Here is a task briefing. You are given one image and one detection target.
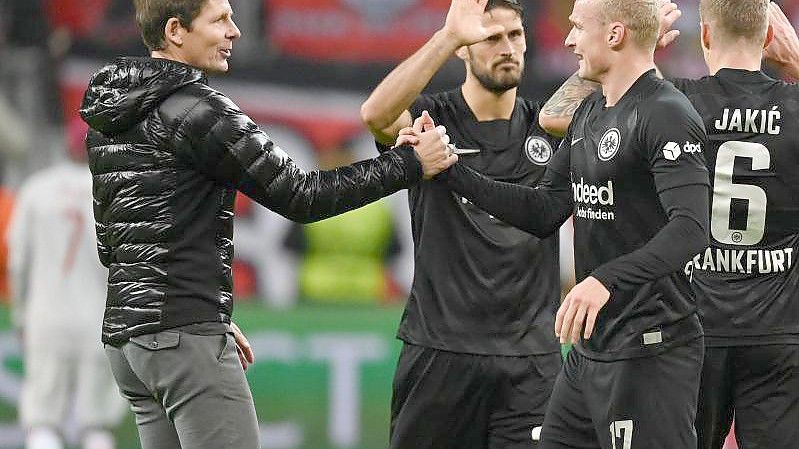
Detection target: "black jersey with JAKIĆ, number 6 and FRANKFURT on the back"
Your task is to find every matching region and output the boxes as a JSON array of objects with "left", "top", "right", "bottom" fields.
[{"left": 673, "top": 69, "right": 799, "bottom": 346}]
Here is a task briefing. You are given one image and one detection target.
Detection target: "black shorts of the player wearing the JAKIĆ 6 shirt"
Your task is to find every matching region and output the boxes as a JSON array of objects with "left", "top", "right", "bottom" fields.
[{"left": 696, "top": 345, "right": 799, "bottom": 449}]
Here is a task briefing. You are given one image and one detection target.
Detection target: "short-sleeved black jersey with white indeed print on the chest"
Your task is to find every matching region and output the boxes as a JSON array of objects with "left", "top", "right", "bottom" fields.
[{"left": 550, "top": 70, "right": 708, "bottom": 360}]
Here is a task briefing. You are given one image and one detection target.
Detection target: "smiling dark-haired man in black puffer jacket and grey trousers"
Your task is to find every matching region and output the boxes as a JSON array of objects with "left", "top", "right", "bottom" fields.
[{"left": 80, "top": 0, "right": 457, "bottom": 449}]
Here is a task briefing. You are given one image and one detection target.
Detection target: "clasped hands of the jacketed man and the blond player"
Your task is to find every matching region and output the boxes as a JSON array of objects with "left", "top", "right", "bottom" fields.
[{"left": 395, "top": 111, "right": 458, "bottom": 179}]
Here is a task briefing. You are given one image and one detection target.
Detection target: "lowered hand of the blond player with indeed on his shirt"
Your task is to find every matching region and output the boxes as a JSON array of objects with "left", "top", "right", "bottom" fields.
[{"left": 555, "top": 276, "right": 610, "bottom": 343}]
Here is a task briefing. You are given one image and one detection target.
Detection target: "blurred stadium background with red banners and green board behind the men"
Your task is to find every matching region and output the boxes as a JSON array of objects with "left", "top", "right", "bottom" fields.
[{"left": 0, "top": 0, "right": 799, "bottom": 449}]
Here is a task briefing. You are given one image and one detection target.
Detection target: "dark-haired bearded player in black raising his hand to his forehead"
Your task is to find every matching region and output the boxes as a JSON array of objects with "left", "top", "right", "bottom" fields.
[{"left": 361, "top": 0, "right": 561, "bottom": 449}]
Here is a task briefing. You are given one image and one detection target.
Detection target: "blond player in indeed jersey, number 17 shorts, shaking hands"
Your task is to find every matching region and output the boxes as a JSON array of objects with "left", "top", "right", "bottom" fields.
[{"left": 440, "top": 0, "right": 709, "bottom": 449}]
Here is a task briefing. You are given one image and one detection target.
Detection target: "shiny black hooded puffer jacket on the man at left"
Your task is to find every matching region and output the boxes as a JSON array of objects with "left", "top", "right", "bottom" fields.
[{"left": 80, "top": 58, "right": 422, "bottom": 345}]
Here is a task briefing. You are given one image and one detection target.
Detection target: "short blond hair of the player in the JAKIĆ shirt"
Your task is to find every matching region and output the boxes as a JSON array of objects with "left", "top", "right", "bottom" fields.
[{"left": 699, "top": 0, "right": 769, "bottom": 44}]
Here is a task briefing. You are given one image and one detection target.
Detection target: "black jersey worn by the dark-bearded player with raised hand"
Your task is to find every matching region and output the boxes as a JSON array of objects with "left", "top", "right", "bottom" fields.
[{"left": 398, "top": 89, "right": 560, "bottom": 355}]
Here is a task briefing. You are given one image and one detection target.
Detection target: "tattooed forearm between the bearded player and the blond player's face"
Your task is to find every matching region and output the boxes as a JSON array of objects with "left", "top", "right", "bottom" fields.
[{"left": 538, "top": 73, "right": 599, "bottom": 137}]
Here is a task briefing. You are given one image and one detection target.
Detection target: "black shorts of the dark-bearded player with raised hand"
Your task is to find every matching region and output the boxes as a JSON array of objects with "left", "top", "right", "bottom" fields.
[{"left": 390, "top": 343, "right": 561, "bottom": 449}]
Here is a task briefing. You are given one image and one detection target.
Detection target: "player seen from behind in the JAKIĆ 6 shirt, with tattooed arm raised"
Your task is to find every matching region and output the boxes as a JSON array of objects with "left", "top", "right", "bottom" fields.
[{"left": 542, "top": 0, "right": 799, "bottom": 449}]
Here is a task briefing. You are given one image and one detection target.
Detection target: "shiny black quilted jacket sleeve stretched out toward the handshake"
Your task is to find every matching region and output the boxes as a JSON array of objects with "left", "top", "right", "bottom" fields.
[{"left": 175, "top": 92, "right": 422, "bottom": 223}]
